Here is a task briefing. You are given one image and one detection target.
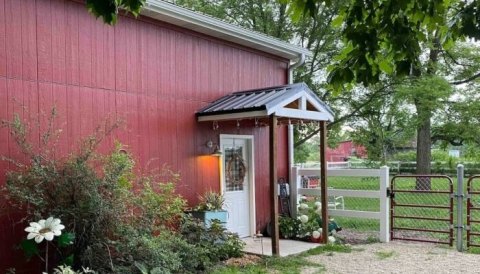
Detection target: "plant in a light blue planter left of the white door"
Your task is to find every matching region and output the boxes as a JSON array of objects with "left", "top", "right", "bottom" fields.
[{"left": 192, "top": 191, "right": 228, "bottom": 227}]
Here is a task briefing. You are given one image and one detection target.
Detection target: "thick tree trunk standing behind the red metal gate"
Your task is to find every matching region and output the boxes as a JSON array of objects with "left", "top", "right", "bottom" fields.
[{"left": 415, "top": 102, "right": 432, "bottom": 190}]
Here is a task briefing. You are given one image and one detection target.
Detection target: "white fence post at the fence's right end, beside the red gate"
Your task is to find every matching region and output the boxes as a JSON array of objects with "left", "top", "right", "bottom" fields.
[{"left": 380, "top": 166, "right": 390, "bottom": 243}]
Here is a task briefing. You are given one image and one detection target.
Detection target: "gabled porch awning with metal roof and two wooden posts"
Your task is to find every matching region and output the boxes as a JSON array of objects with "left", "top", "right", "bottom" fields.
[{"left": 196, "top": 83, "right": 334, "bottom": 255}]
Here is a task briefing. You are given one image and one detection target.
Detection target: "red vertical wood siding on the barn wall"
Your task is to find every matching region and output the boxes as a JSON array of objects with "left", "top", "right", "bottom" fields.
[{"left": 0, "top": 0, "right": 288, "bottom": 273}]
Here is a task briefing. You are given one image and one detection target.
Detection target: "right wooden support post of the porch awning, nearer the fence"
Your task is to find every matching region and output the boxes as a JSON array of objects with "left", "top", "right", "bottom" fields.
[{"left": 320, "top": 121, "right": 329, "bottom": 244}]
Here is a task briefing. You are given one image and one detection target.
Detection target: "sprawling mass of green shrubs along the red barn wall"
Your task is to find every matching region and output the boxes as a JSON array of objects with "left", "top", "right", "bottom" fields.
[{"left": 0, "top": 111, "right": 244, "bottom": 273}]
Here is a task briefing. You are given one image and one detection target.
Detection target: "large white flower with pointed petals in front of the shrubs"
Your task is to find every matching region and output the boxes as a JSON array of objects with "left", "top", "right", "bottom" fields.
[{"left": 25, "top": 217, "right": 65, "bottom": 243}]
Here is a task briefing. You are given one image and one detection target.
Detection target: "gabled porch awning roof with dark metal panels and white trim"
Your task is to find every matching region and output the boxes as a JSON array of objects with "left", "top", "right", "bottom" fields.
[{"left": 196, "top": 83, "right": 333, "bottom": 122}]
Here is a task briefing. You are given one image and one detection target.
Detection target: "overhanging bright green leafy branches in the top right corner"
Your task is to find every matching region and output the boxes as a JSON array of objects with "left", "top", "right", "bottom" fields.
[{"left": 285, "top": 0, "right": 480, "bottom": 88}]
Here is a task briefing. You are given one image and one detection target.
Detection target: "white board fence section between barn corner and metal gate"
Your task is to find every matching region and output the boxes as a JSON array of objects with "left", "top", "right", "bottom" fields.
[{"left": 290, "top": 166, "right": 390, "bottom": 242}]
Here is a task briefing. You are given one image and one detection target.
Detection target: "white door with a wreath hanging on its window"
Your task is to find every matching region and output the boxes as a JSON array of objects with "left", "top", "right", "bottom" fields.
[{"left": 221, "top": 136, "right": 253, "bottom": 237}]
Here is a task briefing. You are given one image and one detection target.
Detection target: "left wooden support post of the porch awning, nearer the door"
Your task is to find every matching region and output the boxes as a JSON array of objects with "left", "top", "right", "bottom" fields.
[{"left": 269, "top": 115, "right": 280, "bottom": 255}]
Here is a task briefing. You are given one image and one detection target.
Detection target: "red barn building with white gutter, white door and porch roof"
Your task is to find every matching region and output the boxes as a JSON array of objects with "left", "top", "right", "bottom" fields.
[{"left": 0, "top": 0, "right": 332, "bottom": 271}]
